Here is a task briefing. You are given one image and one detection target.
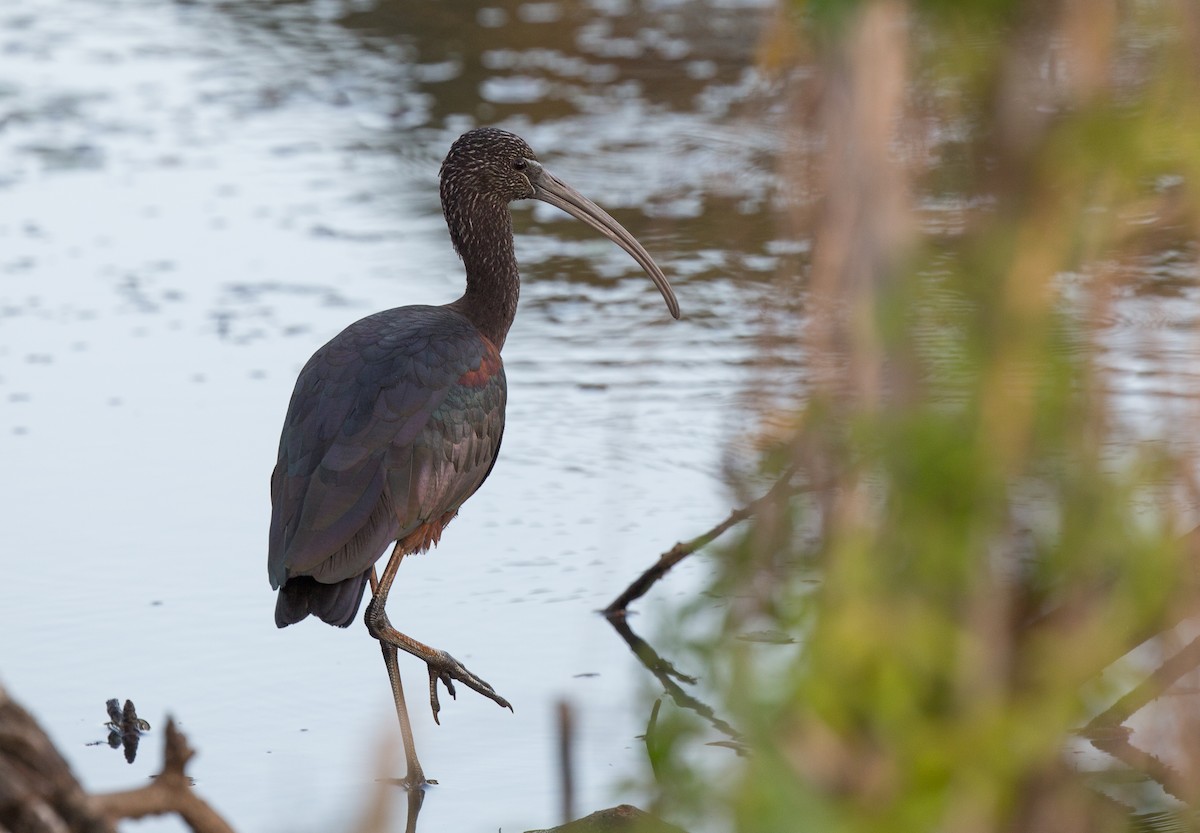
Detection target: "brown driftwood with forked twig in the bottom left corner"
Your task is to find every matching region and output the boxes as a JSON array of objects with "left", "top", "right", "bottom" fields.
[{"left": 0, "top": 688, "right": 233, "bottom": 833}]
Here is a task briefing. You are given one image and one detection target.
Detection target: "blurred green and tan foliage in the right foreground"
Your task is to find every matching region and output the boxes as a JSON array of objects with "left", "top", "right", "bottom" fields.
[{"left": 647, "top": 0, "right": 1200, "bottom": 833}]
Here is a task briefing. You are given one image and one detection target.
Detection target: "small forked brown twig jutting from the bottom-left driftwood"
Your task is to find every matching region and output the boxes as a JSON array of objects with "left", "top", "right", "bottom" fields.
[{"left": 89, "top": 720, "right": 233, "bottom": 833}]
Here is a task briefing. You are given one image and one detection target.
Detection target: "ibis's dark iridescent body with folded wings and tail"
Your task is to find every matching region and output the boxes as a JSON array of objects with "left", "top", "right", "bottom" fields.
[{"left": 268, "top": 306, "right": 506, "bottom": 627}]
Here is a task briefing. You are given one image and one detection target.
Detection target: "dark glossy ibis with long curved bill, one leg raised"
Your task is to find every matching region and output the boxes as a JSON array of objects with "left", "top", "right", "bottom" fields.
[{"left": 268, "top": 128, "right": 679, "bottom": 785}]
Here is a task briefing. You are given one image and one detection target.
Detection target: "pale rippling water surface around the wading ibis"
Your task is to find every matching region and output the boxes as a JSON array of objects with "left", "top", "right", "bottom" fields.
[{"left": 0, "top": 0, "right": 1200, "bottom": 833}]
